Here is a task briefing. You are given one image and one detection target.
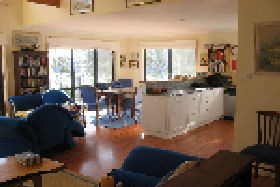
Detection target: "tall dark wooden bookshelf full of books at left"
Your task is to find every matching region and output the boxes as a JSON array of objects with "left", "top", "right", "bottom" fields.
[{"left": 13, "top": 51, "right": 49, "bottom": 95}]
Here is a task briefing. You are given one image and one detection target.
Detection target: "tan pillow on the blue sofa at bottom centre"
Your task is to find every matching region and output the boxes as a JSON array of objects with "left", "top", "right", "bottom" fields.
[{"left": 156, "top": 159, "right": 200, "bottom": 187}]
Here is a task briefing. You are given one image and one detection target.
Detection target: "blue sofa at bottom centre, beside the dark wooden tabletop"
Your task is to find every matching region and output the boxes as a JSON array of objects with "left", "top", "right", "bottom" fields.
[{"left": 110, "top": 146, "right": 203, "bottom": 187}]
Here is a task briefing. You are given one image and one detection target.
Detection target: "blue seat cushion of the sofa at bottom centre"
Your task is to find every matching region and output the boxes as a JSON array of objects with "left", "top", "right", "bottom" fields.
[{"left": 112, "top": 169, "right": 161, "bottom": 187}]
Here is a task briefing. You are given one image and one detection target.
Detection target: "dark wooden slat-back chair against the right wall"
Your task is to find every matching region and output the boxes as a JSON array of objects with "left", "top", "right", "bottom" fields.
[{"left": 241, "top": 111, "right": 280, "bottom": 186}]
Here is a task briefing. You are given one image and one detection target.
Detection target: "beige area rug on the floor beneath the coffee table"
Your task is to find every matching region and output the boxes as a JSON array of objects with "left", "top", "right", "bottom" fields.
[{"left": 23, "top": 169, "right": 99, "bottom": 187}]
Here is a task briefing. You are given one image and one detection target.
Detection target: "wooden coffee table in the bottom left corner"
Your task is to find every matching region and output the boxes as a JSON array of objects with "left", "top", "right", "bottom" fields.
[{"left": 0, "top": 156, "right": 65, "bottom": 187}]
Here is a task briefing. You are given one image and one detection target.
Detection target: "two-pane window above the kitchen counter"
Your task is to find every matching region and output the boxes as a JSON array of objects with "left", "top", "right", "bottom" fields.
[{"left": 144, "top": 49, "right": 196, "bottom": 81}]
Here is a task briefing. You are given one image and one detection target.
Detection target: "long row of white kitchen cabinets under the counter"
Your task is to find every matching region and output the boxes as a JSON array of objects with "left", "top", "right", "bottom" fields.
[{"left": 142, "top": 88, "right": 223, "bottom": 138}]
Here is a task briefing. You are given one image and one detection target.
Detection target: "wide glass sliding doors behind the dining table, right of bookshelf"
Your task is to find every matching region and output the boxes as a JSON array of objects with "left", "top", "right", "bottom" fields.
[{"left": 49, "top": 49, "right": 114, "bottom": 102}]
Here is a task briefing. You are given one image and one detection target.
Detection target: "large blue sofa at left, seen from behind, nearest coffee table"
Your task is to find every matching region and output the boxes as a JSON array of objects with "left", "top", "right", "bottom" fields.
[{"left": 0, "top": 105, "right": 84, "bottom": 158}]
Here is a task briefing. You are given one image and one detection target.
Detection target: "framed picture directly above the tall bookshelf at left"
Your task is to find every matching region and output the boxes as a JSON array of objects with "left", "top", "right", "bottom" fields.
[{"left": 13, "top": 32, "right": 40, "bottom": 47}]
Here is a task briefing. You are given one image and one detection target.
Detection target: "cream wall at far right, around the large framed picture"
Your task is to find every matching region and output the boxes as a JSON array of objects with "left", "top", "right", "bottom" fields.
[{"left": 233, "top": 0, "right": 280, "bottom": 151}]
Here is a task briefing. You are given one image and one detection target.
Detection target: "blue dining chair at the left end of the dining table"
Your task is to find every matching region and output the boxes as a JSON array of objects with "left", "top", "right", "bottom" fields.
[{"left": 81, "top": 85, "right": 106, "bottom": 125}]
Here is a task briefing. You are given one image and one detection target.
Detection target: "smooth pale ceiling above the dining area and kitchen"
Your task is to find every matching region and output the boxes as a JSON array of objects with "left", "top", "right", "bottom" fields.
[{"left": 30, "top": 0, "right": 238, "bottom": 37}]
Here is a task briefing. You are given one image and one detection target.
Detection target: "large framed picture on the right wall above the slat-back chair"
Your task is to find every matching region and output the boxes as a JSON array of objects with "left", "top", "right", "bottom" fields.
[{"left": 255, "top": 22, "right": 280, "bottom": 73}]
